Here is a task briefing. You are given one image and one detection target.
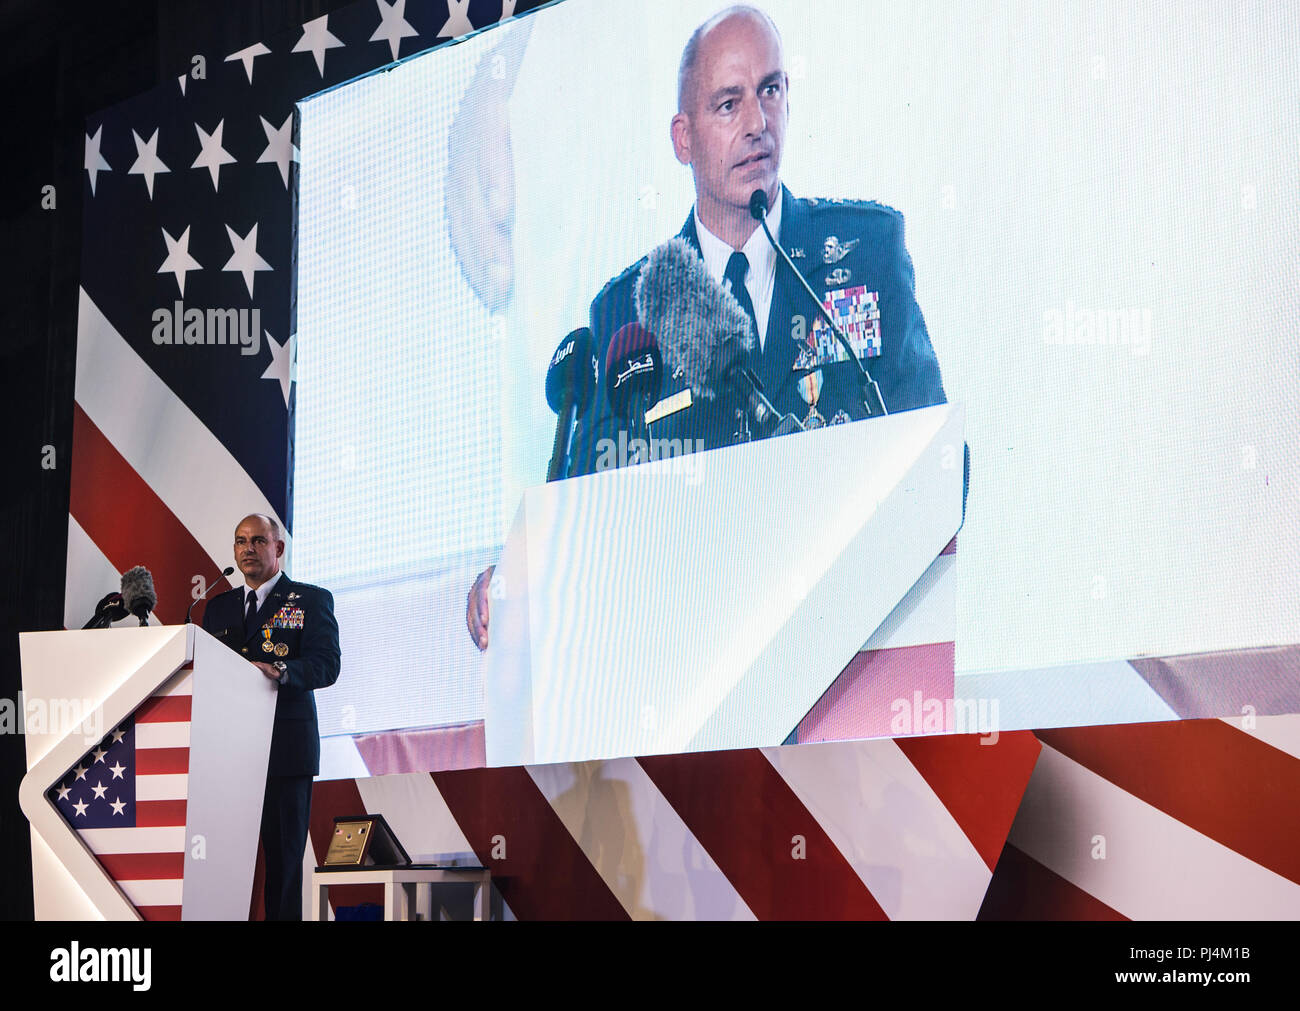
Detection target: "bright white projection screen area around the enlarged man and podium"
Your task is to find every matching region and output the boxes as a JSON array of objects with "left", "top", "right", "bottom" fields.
[{"left": 294, "top": 0, "right": 1300, "bottom": 736}]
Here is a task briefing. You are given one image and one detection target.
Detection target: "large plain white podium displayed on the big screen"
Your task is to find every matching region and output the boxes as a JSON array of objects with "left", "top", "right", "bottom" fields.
[{"left": 484, "top": 404, "right": 965, "bottom": 765}]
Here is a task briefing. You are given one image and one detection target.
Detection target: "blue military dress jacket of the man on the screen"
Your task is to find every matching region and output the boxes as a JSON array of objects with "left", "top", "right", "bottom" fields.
[{"left": 568, "top": 190, "right": 946, "bottom": 476}]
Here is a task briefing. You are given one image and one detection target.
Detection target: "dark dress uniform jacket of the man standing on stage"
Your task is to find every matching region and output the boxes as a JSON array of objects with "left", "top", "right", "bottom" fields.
[{"left": 203, "top": 576, "right": 339, "bottom": 776}]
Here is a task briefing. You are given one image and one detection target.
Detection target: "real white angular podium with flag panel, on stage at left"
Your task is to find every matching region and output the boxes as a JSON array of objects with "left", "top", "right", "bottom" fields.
[{"left": 18, "top": 625, "right": 276, "bottom": 920}]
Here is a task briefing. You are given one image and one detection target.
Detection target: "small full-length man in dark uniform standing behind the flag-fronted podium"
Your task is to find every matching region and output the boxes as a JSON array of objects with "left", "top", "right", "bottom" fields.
[{"left": 203, "top": 513, "right": 339, "bottom": 920}]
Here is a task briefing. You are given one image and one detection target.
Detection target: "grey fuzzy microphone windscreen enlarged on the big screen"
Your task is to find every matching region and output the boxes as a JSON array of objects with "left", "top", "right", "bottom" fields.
[{"left": 636, "top": 238, "right": 754, "bottom": 400}]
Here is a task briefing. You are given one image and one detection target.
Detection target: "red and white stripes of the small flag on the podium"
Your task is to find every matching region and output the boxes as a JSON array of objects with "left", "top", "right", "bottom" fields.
[{"left": 78, "top": 667, "right": 194, "bottom": 920}]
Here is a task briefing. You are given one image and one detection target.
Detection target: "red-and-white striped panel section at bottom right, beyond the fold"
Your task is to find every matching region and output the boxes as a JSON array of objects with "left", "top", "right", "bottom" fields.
[{"left": 991, "top": 716, "right": 1300, "bottom": 920}]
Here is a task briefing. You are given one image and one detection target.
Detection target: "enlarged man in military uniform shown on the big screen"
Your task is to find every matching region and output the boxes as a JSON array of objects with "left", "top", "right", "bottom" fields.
[{"left": 465, "top": 5, "right": 946, "bottom": 648}]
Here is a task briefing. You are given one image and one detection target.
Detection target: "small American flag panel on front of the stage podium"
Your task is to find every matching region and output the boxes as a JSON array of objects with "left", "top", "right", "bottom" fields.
[{"left": 48, "top": 667, "right": 194, "bottom": 920}]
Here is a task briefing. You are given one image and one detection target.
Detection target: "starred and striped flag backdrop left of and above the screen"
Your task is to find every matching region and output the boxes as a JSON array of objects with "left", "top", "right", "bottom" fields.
[{"left": 65, "top": 0, "right": 540, "bottom": 628}]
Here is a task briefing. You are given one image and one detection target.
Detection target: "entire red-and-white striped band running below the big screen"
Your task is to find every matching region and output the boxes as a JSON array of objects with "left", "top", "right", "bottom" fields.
[{"left": 301, "top": 715, "right": 1300, "bottom": 920}]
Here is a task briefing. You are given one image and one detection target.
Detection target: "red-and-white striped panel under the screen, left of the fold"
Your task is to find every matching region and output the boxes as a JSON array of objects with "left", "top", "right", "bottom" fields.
[{"left": 301, "top": 732, "right": 1039, "bottom": 920}]
